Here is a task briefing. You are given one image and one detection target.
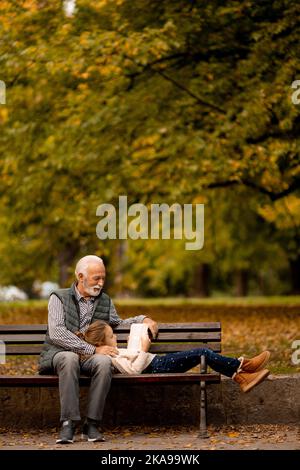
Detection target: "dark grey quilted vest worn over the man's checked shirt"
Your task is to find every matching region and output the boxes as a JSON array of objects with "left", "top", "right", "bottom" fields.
[{"left": 39, "top": 284, "right": 111, "bottom": 374}]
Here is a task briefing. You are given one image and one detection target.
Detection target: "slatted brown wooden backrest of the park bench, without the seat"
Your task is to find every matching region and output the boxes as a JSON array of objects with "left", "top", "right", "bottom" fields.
[{"left": 0, "top": 322, "right": 221, "bottom": 356}]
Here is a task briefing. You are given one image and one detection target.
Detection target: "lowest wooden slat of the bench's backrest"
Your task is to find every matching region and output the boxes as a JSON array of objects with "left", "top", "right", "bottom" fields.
[{"left": 6, "top": 343, "right": 221, "bottom": 356}]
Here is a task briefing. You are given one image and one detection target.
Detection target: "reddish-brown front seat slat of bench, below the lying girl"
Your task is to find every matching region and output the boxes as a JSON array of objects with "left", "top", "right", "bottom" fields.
[{"left": 0, "top": 373, "right": 220, "bottom": 387}]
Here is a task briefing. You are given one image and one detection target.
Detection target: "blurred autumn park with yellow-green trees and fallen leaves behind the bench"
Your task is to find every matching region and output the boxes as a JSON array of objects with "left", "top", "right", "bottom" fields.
[{"left": 0, "top": 0, "right": 300, "bottom": 373}]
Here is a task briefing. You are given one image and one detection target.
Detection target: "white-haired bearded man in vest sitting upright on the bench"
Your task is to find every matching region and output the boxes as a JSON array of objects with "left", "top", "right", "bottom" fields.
[{"left": 39, "top": 255, "right": 158, "bottom": 444}]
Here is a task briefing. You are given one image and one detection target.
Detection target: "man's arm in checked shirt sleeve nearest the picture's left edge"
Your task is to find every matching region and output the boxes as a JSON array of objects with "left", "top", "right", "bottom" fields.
[{"left": 48, "top": 294, "right": 96, "bottom": 354}]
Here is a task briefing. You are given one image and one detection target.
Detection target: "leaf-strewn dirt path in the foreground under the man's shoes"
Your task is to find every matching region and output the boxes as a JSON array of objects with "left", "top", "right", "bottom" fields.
[{"left": 0, "top": 425, "right": 300, "bottom": 450}]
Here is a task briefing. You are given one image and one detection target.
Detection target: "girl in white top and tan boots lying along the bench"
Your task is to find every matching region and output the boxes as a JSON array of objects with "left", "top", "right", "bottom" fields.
[{"left": 77, "top": 320, "right": 270, "bottom": 392}]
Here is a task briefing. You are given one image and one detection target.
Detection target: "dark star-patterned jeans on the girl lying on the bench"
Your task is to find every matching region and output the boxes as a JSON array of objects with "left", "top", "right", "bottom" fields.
[{"left": 143, "top": 348, "right": 241, "bottom": 377}]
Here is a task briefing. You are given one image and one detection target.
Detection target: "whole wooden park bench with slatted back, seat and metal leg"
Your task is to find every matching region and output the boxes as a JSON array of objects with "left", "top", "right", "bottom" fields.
[{"left": 0, "top": 322, "right": 221, "bottom": 438}]
